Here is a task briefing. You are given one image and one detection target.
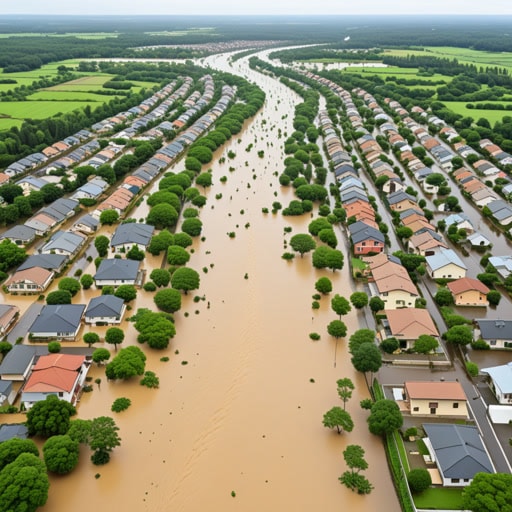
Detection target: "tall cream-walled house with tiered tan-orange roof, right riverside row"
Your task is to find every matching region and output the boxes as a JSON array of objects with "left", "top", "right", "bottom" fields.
[{"left": 369, "top": 254, "right": 419, "bottom": 309}]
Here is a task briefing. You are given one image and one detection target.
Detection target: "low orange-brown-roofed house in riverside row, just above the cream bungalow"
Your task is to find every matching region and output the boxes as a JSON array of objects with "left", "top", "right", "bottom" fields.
[{"left": 384, "top": 308, "right": 439, "bottom": 348}]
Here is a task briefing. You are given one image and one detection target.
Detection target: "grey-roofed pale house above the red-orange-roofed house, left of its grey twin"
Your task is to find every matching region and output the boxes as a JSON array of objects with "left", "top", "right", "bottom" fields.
[{"left": 29, "top": 304, "right": 85, "bottom": 341}]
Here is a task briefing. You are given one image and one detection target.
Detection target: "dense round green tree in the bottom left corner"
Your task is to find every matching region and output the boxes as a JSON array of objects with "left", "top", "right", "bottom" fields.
[{"left": 0, "top": 453, "right": 50, "bottom": 512}]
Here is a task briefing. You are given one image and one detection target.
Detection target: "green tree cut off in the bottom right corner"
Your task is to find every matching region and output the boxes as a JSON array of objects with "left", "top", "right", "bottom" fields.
[{"left": 462, "top": 473, "right": 512, "bottom": 512}]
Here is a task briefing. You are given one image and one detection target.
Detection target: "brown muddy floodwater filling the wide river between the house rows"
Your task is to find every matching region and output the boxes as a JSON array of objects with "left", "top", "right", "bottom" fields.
[{"left": 40, "top": 49, "right": 400, "bottom": 512}]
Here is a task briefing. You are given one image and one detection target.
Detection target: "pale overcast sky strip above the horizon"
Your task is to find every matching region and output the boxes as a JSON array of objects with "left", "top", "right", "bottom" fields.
[{"left": 0, "top": 0, "right": 512, "bottom": 15}]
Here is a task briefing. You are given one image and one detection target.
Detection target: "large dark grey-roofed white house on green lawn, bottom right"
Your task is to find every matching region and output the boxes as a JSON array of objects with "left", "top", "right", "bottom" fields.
[{"left": 423, "top": 423, "right": 494, "bottom": 487}]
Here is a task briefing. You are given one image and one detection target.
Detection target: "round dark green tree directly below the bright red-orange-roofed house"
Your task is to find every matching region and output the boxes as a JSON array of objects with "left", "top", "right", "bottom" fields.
[{"left": 26, "top": 395, "right": 76, "bottom": 437}]
